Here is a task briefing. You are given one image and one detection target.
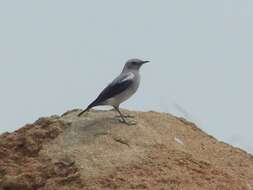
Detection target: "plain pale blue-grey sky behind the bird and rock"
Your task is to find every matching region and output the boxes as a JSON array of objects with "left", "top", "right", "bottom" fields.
[{"left": 0, "top": 0, "right": 253, "bottom": 152}]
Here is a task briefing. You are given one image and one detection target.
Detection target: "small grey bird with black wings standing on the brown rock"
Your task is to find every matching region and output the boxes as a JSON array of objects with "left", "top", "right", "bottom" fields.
[{"left": 78, "top": 58, "right": 149, "bottom": 125}]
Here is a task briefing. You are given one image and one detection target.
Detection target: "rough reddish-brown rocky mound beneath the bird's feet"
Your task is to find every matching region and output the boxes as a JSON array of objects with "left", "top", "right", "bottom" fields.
[{"left": 0, "top": 110, "right": 253, "bottom": 190}]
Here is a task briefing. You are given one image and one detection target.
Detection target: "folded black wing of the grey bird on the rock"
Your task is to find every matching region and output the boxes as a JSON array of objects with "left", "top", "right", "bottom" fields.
[{"left": 88, "top": 73, "right": 134, "bottom": 109}]
